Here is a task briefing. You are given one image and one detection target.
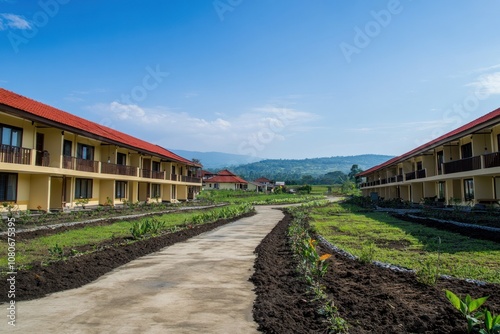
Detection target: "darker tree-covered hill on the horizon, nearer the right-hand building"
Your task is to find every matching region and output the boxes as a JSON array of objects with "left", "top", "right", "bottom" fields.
[{"left": 231, "top": 154, "right": 393, "bottom": 180}]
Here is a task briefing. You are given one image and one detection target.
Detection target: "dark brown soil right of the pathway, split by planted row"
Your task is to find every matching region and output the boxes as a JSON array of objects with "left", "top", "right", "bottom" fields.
[{"left": 251, "top": 216, "right": 500, "bottom": 333}]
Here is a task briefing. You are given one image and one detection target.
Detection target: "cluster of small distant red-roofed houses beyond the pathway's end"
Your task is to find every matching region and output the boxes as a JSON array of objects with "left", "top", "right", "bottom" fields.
[{"left": 201, "top": 169, "right": 277, "bottom": 192}]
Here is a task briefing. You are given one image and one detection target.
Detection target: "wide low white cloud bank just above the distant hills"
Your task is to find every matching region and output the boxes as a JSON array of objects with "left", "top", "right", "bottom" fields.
[{"left": 86, "top": 101, "right": 316, "bottom": 153}]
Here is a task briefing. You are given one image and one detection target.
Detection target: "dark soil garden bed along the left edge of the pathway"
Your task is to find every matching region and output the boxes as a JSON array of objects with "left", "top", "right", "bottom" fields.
[{"left": 0, "top": 213, "right": 254, "bottom": 303}]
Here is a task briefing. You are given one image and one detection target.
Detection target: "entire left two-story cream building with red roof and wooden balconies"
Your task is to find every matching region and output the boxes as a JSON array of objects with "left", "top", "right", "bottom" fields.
[{"left": 0, "top": 88, "right": 202, "bottom": 210}]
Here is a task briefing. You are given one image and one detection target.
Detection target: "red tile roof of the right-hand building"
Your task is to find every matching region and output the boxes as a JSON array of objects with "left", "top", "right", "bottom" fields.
[{"left": 357, "top": 108, "right": 500, "bottom": 176}]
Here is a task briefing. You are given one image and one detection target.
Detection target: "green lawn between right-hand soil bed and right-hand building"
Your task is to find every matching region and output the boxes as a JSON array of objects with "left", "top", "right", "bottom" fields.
[{"left": 311, "top": 204, "right": 500, "bottom": 283}]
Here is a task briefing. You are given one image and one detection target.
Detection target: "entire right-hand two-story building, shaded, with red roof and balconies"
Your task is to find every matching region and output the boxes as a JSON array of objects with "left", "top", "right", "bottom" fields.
[{"left": 357, "top": 108, "right": 500, "bottom": 205}]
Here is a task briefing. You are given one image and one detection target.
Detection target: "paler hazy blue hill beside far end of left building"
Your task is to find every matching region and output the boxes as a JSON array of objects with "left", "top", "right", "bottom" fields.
[{"left": 170, "top": 149, "right": 262, "bottom": 170}]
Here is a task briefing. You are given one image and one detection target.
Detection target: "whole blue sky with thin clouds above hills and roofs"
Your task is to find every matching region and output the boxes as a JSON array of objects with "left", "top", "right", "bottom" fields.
[{"left": 0, "top": 0, "right": 500, "bottom": 158}]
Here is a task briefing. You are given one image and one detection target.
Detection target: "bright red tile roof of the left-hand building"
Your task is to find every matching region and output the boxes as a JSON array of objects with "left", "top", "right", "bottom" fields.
[{"left": 0, "top": 88, "right": 200, "bottom": 167}]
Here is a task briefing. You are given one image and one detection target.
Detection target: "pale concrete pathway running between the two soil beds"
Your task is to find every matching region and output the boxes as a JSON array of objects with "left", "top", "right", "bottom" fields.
[{"left": 5, "top": 207, "right": 283, "bottom": 333}]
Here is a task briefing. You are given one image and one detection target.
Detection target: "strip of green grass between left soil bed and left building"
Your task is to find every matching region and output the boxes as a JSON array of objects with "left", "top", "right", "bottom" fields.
[{"left": 0, "top": 206, "right": 249, "bottom": 270}]
